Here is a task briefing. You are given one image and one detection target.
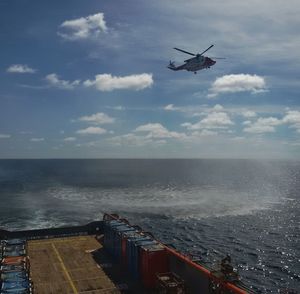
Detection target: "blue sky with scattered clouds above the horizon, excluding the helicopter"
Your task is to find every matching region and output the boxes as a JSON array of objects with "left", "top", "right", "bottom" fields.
[{"left": 0, "top": 0, "right": 300, "bottom": 160}]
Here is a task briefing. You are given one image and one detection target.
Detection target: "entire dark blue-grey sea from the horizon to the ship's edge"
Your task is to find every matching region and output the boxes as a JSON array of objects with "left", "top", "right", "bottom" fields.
[{"left": 0, "top": 159, "right": 300, "bottom": 293}]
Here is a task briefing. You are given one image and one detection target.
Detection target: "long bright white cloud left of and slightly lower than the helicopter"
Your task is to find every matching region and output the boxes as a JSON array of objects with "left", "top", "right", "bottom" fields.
[{"left": 83, "top": 73, "right": 153, "bottom": 91}]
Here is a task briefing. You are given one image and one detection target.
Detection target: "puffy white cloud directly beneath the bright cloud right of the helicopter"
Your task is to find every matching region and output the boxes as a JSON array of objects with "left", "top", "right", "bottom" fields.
[{"left": 183, "top": 112, "right": 234, "bottom": 130}]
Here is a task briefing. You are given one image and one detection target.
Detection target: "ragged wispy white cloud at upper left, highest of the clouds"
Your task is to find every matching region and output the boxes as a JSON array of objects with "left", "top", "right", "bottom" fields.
[{"left": 58, "top": 12, "right": 107, "bottom": 41}]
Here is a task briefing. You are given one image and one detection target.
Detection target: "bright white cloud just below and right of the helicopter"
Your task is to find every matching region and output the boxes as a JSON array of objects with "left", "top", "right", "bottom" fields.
[{"left": 207, "top": 74, "right": 267, "bottom": 98}]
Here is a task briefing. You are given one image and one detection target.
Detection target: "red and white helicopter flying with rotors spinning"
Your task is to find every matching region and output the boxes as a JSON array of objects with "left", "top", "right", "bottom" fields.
[{"left": 167, "top": 45, "right": 225, "bottom": 74}]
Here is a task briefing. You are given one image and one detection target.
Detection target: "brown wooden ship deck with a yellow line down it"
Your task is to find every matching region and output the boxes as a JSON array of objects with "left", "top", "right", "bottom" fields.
[{"left": 28, "top": 236, "right": 120, "bottom": 294}]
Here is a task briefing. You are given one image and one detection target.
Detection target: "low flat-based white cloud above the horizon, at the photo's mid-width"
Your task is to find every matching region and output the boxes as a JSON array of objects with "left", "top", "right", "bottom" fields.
[{"left": 134, "top": 123, "right": 185, "bottom": 139}]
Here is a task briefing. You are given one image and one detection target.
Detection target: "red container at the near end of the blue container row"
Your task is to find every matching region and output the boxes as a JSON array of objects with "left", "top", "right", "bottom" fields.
[{"left": 140, "top": 244, "right": 169, "bottom": 288}]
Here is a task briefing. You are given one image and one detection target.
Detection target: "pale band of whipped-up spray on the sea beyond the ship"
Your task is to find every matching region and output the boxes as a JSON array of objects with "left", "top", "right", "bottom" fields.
[{"left": 47, "top": 186, "right": 278, "bottom": 218}]
